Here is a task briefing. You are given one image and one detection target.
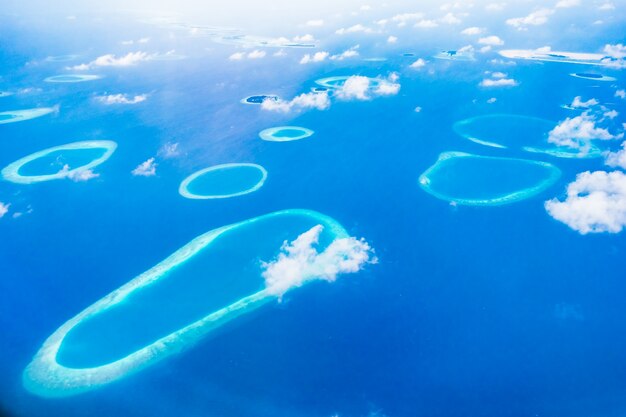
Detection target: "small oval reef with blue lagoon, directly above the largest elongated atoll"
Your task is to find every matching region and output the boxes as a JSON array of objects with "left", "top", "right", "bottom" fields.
[{"left": 178, "top": 163, "right": 267, "bottom": 200}]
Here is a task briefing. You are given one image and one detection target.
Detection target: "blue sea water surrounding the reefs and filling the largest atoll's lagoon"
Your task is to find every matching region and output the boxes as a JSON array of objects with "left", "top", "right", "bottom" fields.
[{"left": 0, "top": 5, "right": 626, "bottom": 417}]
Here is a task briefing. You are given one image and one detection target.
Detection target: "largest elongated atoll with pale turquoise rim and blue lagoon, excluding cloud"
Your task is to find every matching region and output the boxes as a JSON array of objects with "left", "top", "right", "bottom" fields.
[{"left": 22, "top": 209, "right": 349, "bottom": 397}]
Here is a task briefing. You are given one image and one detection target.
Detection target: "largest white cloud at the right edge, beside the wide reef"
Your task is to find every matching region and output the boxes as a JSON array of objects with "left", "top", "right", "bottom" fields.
[{"left": 545, "top": 171, "right": 626, "bottom": 234}]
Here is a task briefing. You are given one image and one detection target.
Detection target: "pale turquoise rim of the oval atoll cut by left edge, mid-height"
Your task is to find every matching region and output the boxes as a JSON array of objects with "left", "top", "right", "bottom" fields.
[{"left": 1, "top": 140, "right": 117, "bottom": 184}]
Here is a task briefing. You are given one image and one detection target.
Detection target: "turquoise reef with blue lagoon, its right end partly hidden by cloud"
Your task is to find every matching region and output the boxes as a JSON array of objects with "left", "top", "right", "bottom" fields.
[{"left": 453, "top": 114, "right": 602, "bottom": 158}]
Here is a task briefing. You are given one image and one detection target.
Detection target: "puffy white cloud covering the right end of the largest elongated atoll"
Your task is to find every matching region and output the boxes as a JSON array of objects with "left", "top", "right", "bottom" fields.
[{"left": 261, "top": 225, "right": 376, "bottom": 297}]
